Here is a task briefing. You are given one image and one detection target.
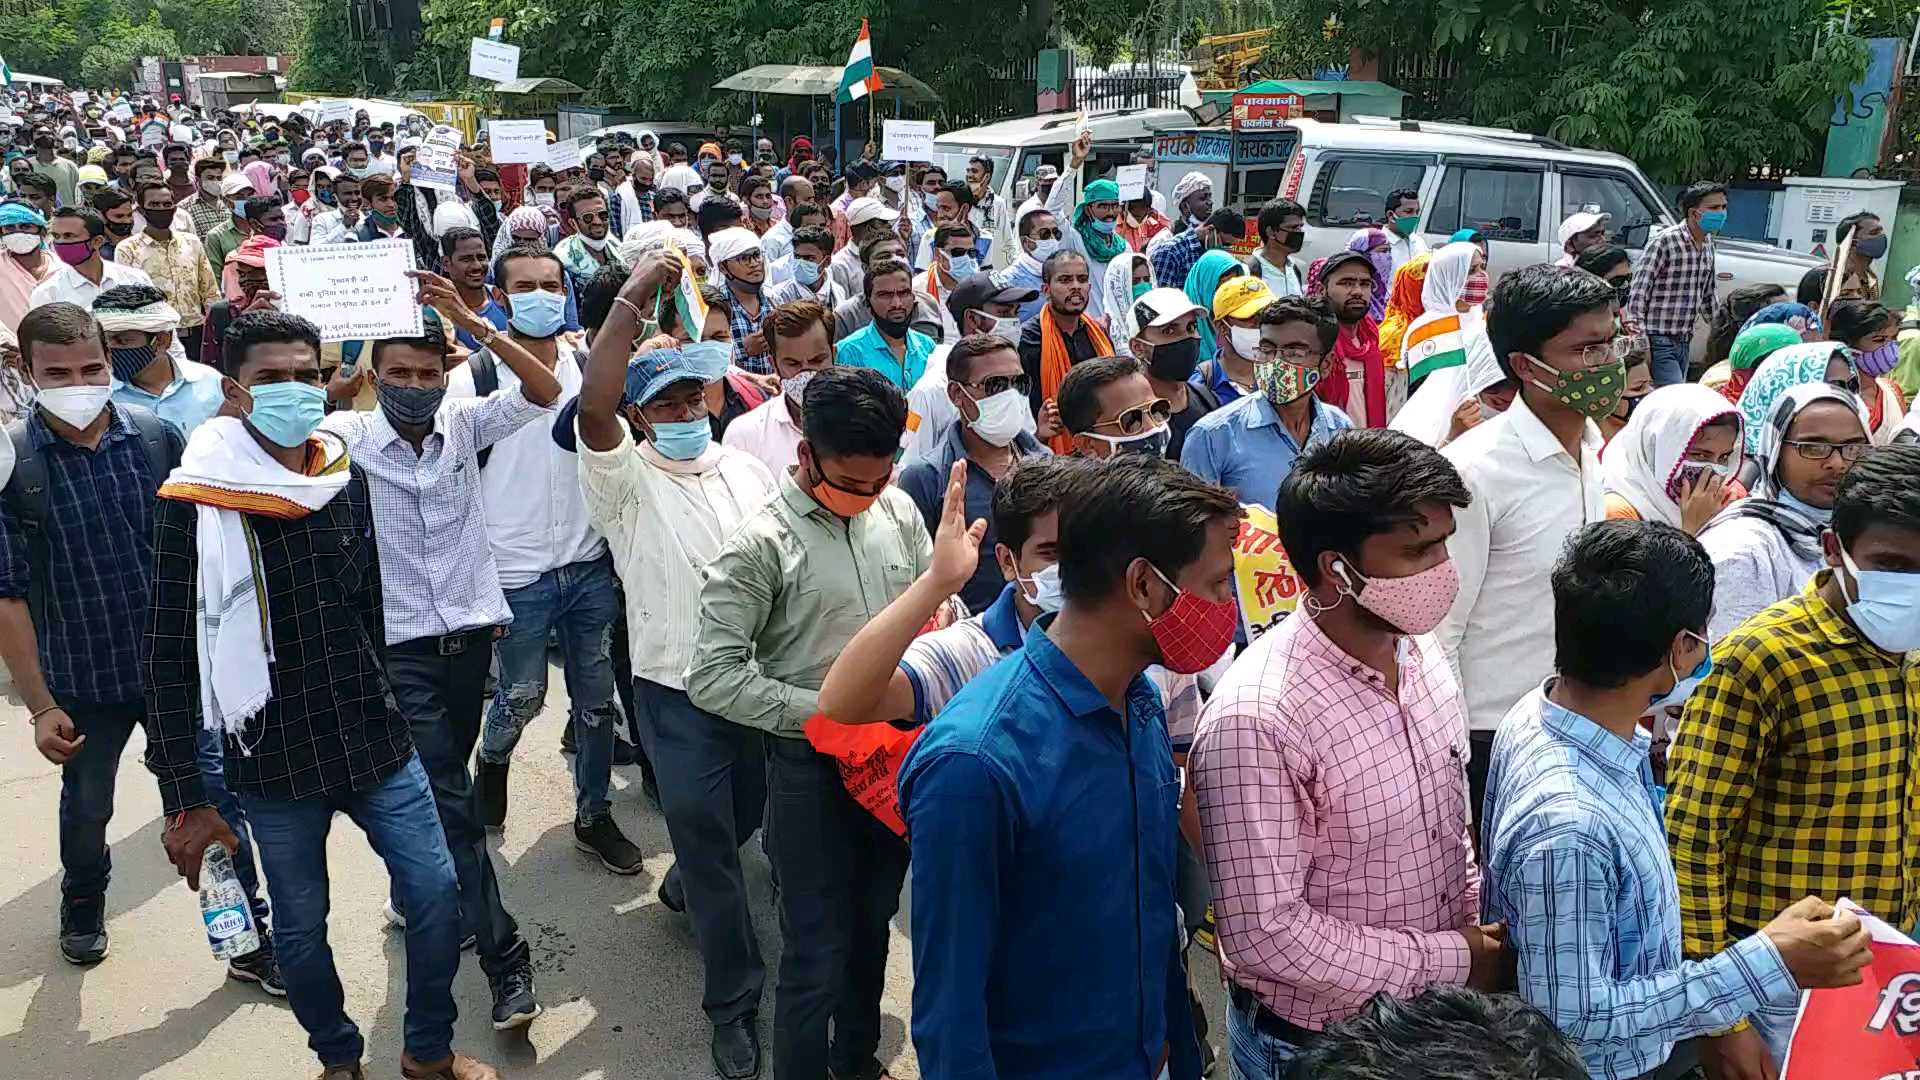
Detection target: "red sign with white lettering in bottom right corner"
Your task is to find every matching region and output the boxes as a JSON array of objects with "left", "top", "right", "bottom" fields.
[{"left": 1780, "top": 899, "right": 1920, "bottom": 1080}]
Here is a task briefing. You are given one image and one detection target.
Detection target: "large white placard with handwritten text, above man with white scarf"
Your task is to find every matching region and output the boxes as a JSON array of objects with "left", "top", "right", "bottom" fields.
[{"left": 267, "top": 240, "right": 422, "bottom": 342}]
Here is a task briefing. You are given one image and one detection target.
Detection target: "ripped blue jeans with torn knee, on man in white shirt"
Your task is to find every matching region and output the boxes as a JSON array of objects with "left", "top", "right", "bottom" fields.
[{"left": 480, "top": 555, "right": 620, "bottom": 824}]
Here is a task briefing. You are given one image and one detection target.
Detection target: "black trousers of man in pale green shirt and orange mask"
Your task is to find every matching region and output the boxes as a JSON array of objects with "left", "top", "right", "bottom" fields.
[{"left": 766, "top": 736, "right": 906, "bottom": 1080}]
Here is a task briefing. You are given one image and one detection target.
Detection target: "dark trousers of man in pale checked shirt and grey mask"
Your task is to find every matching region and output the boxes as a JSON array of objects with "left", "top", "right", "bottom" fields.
[{"left": 386, "top": 626, "right": 528, "bottom": 978}]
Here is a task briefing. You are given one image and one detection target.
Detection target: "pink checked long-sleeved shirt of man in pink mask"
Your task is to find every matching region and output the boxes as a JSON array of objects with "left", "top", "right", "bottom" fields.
[{"left": 1187, "top": 609, "right": 1480, "bottom": 1030}]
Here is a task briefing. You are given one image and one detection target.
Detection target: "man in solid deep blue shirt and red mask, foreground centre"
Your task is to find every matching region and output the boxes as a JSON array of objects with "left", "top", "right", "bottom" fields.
[{"left": 899, "top": 449, "right": 1240, "bottom": 1080}]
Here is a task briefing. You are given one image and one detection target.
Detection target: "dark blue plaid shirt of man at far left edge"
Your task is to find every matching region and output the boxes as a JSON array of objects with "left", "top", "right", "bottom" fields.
[{"left": 0, "top": 405, "right": 184, "bottom": 703}]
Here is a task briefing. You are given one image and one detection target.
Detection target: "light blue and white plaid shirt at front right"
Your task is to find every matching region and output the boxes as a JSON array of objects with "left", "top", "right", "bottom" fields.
[{"left": 1482, "top": 682, "right": 1799, "bottom": 1080}]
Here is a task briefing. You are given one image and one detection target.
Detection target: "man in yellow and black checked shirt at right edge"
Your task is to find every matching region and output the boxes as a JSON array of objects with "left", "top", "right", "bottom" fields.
[{"left": 1667, "top": 446, "right": 1920, "bottom": 1076}]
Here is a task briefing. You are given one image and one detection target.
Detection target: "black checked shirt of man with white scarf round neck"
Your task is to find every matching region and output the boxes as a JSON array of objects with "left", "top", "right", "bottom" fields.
[{"left": 140, "top": 467, "right": 413, "bottom": 815}]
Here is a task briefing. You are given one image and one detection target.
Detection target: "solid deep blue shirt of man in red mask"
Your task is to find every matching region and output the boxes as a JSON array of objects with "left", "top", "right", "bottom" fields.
[{"left": 899, "top": 628, "right": 1198, "bottom": 1080}]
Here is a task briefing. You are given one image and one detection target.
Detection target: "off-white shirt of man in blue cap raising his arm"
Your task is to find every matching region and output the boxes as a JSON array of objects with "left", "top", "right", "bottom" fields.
[{"left": 580, "top": 424, "right": 776, "bottom": 690}]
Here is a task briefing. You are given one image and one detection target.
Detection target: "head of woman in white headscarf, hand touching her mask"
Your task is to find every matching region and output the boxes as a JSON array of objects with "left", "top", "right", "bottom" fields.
[{"left": 1599, "top": 382, "right": 1745, "bottom": 534}]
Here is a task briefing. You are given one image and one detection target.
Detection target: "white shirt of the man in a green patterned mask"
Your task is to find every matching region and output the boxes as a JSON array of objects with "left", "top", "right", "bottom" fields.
[{"left": 1440, "top": 398, "right": 1607, "bottom": 732}]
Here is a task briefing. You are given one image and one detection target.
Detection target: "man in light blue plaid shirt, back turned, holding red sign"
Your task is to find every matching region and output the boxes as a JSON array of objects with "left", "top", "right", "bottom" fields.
[{"left": 1484, "top": 521, "right": 1872, "bottom": 1076}]
